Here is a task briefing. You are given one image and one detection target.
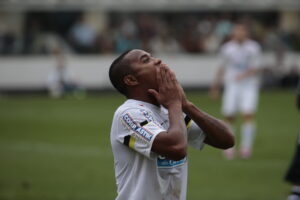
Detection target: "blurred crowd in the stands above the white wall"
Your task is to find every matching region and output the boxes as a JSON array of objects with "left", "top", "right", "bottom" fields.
[{"left": 0, "top": 12, "right": 300, "bottom": 55}]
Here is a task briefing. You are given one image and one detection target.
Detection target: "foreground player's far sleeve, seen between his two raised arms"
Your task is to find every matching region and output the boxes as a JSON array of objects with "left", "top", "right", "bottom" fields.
[{"left": 184, "top": 116, "right": 205, "bottom": 150}]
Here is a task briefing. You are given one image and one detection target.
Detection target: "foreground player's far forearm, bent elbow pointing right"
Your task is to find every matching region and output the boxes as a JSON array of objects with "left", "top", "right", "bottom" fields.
[{"left": 183, "top": 102, "right": 234, "bottom": 149}]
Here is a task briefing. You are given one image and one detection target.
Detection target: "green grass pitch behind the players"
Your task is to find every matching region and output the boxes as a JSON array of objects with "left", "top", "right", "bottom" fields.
[{"left": 0, "top": 90, "right": 300, "bottom": 200}]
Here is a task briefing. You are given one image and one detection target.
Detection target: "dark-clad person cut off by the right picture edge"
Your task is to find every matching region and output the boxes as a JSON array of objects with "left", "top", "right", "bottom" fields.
[{"left": 285, "top": 81, "right": 300, "bottom": 200}]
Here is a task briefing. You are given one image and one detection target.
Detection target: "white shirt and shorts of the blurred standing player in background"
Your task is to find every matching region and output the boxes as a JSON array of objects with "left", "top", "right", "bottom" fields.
[{"left": 221, "top": 40, "right": 261, "bottom": 116}]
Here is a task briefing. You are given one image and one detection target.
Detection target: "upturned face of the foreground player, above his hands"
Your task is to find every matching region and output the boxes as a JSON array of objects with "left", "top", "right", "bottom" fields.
[{"left": 128, "top": 50, "right": 162, "bottom": 90}]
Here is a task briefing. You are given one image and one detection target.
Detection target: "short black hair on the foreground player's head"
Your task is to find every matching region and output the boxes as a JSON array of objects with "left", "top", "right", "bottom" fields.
[{"left": 109, "top": 50, "right": 132, "bottom": 96}]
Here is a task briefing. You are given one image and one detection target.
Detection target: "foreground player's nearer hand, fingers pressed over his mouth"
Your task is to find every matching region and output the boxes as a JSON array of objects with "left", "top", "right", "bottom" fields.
[{"left": 148, "top": 65, "right": 182, "bottom": 109}]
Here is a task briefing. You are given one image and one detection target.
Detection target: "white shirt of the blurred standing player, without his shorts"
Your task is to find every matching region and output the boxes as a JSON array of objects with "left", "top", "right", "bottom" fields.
[{"left": 221, "top": 40, "right": 261, "bottom": 86}]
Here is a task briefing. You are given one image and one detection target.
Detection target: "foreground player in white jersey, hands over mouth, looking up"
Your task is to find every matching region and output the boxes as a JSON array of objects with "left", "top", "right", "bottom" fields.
[{"left": 109, "top": 49, "right": 234, "bottom": 200}]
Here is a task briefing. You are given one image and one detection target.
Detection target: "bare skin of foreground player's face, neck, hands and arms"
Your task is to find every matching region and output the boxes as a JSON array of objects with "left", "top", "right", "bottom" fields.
[{"left": 123, "top": 50, "right": 234, "bottom": 160}]
